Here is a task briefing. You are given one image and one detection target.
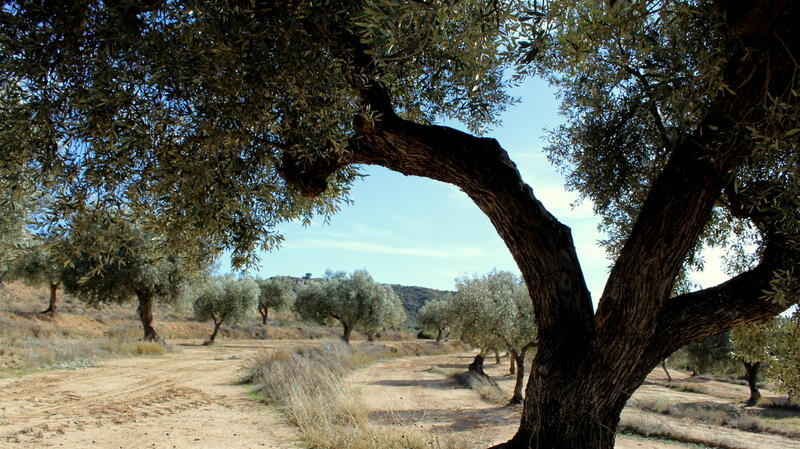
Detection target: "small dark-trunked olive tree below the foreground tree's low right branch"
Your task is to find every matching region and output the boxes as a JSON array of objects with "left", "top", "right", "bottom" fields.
[{"left": 731, "top": 318, "right": 779, "bottom": 405}]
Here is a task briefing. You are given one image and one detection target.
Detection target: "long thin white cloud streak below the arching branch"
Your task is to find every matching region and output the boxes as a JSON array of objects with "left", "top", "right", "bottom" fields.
[{"left": 284, "top": 239, "right": 486, "bottom": 259}]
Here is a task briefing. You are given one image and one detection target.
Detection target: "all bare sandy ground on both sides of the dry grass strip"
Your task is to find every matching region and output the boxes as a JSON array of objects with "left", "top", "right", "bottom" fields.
[{"left": 0, "top": 340, "right": 800, "bottom": 449}]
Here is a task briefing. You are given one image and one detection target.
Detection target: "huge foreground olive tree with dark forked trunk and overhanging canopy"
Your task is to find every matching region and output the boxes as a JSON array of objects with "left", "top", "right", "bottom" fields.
[{"left": 0, "top": 0, "right": 800, "bottom": 449}]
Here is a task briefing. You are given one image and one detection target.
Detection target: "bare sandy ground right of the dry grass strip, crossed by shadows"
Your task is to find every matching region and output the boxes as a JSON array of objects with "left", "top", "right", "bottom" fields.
[{"left": 349, "top": 354, "right": 800, "bottom": 449}]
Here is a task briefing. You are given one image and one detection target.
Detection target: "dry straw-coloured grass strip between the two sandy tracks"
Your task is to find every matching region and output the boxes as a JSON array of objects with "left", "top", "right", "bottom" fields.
[{"left": 242, "top": 342, "right": 467, "bottom": 449}]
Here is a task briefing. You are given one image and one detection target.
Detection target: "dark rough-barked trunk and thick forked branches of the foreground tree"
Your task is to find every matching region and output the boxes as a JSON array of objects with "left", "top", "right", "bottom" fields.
[{"left": 276, "top": 0, "right": 800, "bottom": 449}]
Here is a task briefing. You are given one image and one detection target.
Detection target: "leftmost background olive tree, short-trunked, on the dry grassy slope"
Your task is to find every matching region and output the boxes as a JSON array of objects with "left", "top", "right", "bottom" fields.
[{"left": 8, "top": 242, "right": 64, "bottom": 316}]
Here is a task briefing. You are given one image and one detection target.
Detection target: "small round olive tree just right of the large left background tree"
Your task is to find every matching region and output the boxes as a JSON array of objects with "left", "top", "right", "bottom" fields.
[{"left": 192, "top": 278, "right": 259, "bottom": 343}]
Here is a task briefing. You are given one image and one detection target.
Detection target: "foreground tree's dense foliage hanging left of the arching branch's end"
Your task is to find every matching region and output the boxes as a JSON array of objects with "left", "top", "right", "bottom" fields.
[{"left": 0, "top": 0, "right": 519, "bottom": 266}]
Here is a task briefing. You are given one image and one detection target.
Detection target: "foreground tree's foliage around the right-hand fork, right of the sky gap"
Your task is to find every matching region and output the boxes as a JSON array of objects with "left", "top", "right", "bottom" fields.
[{"left": 526, "top": 0, "right": 800, "bottom": 290}]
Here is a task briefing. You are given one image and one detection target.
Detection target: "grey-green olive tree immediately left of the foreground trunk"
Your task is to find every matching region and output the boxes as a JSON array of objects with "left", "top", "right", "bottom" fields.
[{"left": 450, "top": 271, "right": 537, "bottom": 404}]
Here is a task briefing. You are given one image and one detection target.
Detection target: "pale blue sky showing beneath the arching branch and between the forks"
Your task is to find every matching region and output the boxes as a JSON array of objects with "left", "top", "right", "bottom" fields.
[{"left": 227, "top": 79, "right": 732, "bottom": 299}]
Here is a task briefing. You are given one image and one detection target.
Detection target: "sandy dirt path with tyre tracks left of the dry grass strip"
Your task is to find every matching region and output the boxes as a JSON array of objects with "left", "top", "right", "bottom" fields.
[{"left": 0, "top": 340, "right": 301, "bottom": 449}]
